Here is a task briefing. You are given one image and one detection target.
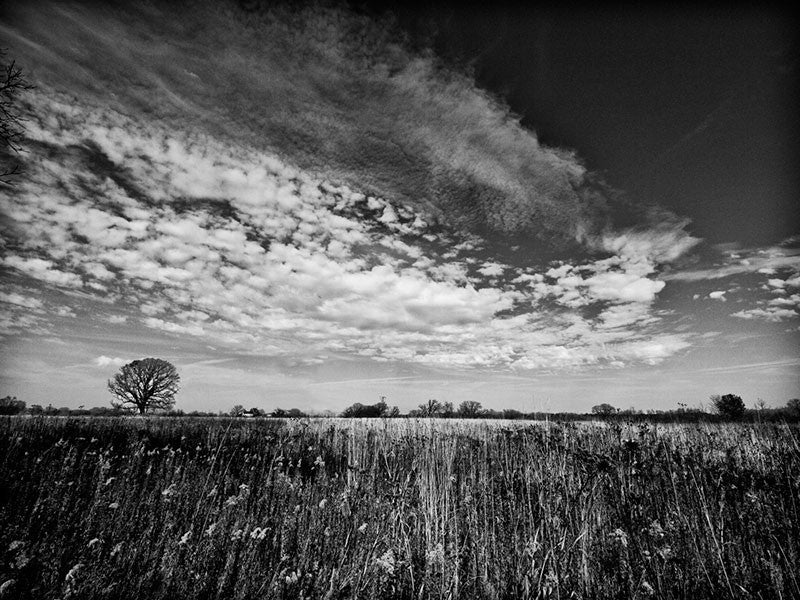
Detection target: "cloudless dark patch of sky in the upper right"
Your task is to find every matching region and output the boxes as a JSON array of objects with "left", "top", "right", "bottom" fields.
[{"left": 360, "top": 3, "right": 800, "bottom": 244}]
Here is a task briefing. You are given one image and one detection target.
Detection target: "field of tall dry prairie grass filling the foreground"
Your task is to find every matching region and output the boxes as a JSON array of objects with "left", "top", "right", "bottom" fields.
[{"left": 0, "top": 417, "right": 800, "bottom": 600}]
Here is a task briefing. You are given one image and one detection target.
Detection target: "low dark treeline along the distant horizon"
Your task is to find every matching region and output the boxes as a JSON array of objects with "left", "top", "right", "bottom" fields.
[{"left": 0, "top": 396, "right": 800, "bottom": 423}]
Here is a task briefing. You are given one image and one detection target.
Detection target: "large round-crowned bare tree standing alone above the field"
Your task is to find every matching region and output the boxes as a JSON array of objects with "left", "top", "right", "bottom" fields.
[{"left": 108, "top": 358, "right": 181, "bottom": 415}]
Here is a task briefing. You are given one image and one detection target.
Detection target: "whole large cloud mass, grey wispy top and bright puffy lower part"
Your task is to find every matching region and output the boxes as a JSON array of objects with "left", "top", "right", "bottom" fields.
[{"left": 3, "top": 3, "right": 698, "bottom": 370}]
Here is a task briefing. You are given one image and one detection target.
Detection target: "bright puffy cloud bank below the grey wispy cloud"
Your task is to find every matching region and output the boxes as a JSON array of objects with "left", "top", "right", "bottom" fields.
[{"left": 4, "top": 92, "right": 696, "bottom": 369}]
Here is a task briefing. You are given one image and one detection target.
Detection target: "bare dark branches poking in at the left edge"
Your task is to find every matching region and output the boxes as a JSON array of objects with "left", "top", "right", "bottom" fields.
[{"left": 0, "top": 50, "right": 33, "bottom": 185}]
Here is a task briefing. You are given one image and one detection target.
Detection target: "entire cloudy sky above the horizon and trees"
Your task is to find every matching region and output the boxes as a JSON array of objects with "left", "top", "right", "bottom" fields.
[{"left": 0, "top": 0, "right": 800, "bottom": 412}]
